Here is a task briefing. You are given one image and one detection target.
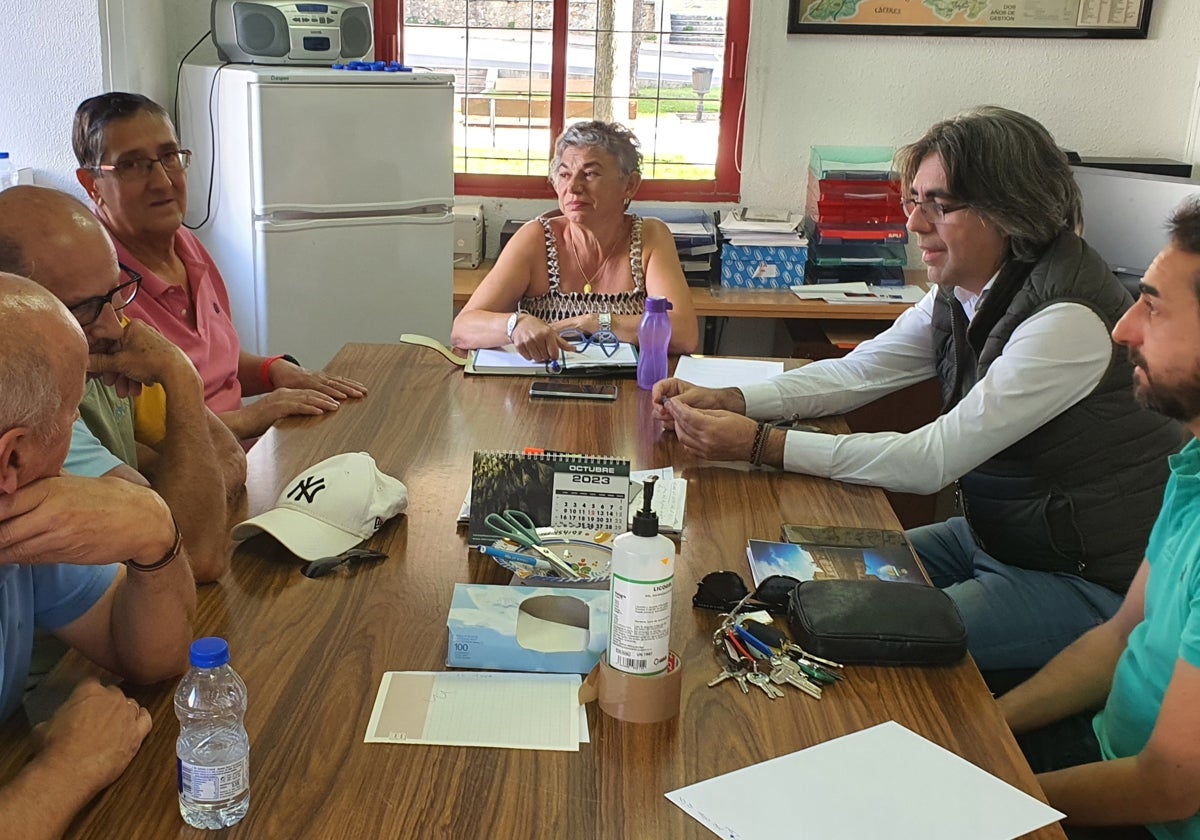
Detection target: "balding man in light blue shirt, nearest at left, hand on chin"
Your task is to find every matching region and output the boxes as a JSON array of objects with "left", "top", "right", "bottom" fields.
[{"left": 0, "top": 274, "right": 196, "bottom": 839}]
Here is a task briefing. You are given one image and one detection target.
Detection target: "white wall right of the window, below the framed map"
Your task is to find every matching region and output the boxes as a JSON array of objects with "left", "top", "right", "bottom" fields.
[{"left": 742, "top": 0, "right": 1200, "bottom": 205}]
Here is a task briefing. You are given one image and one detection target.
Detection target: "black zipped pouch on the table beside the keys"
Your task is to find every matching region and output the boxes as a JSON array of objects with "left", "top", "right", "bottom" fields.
[{"left": 787, "top": 580, "right": 967, "bottom": 665}]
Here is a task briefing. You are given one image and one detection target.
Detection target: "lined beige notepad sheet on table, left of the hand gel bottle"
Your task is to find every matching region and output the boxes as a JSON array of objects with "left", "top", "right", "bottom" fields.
[{"left": 362, "top": 671, "right": 581, "bottom": 752}]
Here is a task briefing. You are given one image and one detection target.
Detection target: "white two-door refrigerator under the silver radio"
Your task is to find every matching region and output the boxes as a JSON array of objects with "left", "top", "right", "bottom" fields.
[{"left": 179, "top": 64, "right": 454, "bottom": 370}]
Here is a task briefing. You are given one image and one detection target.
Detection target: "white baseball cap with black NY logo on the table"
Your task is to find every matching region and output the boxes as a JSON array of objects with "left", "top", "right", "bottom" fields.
[{"left": 233, "top": 452, "right": 408, "bottom": 560}]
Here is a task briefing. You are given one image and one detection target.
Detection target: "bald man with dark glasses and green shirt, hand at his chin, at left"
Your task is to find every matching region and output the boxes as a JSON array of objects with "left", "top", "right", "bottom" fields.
[{"left": 0, "top": 186, "right": 246, "bottom": 582}]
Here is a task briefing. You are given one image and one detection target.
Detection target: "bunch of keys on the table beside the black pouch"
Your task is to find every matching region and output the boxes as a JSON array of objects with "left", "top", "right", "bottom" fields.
[{"left": 708, "top": 590, "right": 844, "bottom": 700}]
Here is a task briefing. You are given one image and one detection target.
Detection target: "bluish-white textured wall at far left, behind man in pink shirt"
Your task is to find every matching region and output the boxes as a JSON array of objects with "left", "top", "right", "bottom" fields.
[{"left": 0, "top": 0, "right": 103, "bottom": 188}]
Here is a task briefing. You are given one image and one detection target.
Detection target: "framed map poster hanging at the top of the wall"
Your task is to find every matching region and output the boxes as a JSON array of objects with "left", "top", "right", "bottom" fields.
[{"left": 787, "top": 0, "right": 1151, "bottom": 38}]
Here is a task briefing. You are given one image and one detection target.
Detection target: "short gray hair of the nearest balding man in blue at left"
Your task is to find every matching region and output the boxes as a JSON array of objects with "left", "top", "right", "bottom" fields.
[{"left": 0, "top": 277, "right": 62, "bottom": 440}]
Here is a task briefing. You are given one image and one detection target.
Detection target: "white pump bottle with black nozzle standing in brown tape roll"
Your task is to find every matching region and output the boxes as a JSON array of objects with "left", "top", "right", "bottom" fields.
[{"left": 608, "top": 480, "right": 674, "bottom": 676}]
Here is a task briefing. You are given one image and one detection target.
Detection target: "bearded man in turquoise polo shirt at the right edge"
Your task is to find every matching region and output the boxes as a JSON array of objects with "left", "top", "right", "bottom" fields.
[{"left": 1000, "top": 196, "right": 1200, "bottom": 840}]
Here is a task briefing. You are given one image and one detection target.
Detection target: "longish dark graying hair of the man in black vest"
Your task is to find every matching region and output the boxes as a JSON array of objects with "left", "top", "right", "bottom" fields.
[{"left": 896, "top": 106, "right": 1082, "bottom": 263}]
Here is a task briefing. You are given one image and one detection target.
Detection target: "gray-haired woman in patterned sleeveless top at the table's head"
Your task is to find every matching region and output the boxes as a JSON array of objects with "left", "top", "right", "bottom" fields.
[{"left": 451, "top": 121, "right": 700, "bottom": 361}]
